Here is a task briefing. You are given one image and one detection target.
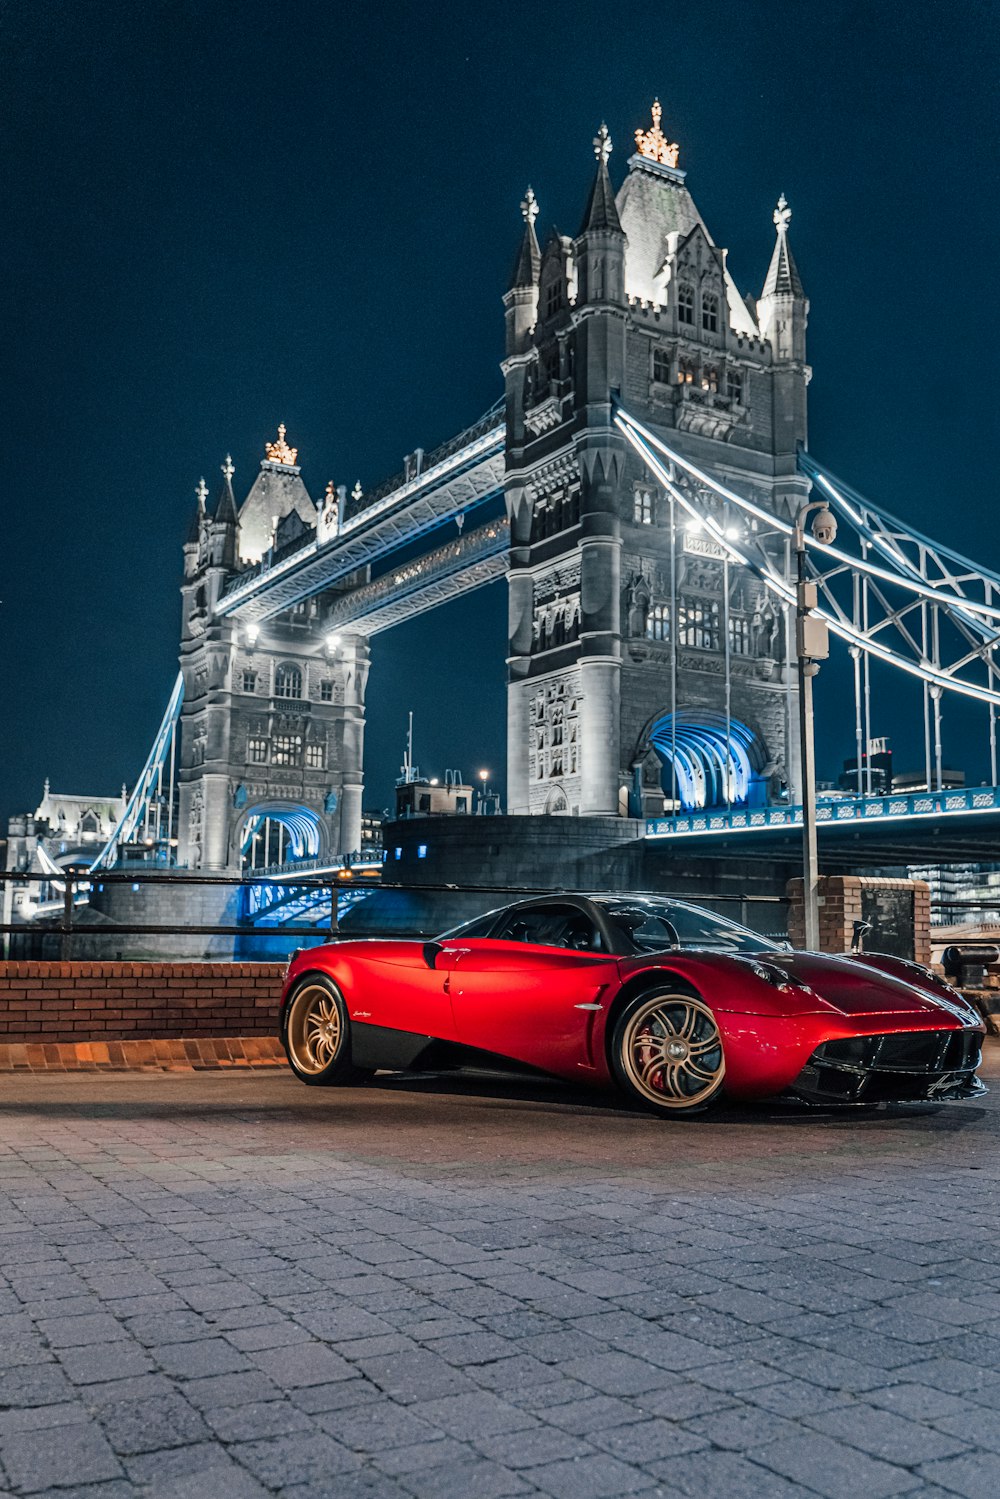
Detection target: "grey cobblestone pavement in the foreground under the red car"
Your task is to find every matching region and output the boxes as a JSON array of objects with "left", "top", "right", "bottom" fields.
[{"left": 0, "top": 1054, "right": 1000, "bottom": 1499}]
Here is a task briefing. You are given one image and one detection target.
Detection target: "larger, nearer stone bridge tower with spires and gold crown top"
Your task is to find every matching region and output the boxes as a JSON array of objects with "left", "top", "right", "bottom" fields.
[{"left": 504, "top": 103, "right": 811, "bottom": 815}]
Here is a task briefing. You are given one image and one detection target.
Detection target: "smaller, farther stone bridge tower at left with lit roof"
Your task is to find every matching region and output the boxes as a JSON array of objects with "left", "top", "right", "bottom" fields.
[{"left": 177, "top": 427, "right": 369, "bottom": 869}]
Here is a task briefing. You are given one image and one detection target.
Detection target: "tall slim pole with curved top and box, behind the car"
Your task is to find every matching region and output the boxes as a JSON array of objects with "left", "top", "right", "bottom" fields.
[{"left": 795, "top": 499, "right": 837, "bottom": 952}]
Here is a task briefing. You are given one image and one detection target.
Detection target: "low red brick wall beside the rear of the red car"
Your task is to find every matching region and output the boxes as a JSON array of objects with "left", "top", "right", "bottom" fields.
[{"left": 0, "top": 962, "right": 283, "bottom": 1046}]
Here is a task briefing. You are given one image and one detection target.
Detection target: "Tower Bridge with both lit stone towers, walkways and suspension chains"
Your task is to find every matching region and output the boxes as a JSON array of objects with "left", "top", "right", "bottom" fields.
[{"left": 72, "top": 103, "right": 1000, "bottom": 911}]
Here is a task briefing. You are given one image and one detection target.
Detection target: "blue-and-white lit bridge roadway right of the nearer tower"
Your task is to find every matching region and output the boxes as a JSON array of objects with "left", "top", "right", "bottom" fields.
[{"left": 646, "top": 785, "right": 1000, "bottom": 874}]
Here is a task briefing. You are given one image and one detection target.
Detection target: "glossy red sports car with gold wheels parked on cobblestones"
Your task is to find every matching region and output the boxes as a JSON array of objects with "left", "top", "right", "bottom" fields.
[{"left": 280, "top": 895, "right": 985, "bottom": 1115}]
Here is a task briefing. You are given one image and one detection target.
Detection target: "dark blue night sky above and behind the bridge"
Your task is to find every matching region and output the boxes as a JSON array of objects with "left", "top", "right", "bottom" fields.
[{"left": 0, "top": 0, "right": 1000, "bottom": 820}]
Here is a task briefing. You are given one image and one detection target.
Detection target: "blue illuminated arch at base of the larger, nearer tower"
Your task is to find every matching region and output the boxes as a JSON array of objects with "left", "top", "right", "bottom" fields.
[{"left": 649, "top": 709, "right": 766, "bottom": 811}]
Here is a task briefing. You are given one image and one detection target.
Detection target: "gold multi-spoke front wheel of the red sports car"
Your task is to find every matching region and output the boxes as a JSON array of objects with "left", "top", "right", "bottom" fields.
[{"left": 621, "top": 994, "right": 726, "bottom": 1109}]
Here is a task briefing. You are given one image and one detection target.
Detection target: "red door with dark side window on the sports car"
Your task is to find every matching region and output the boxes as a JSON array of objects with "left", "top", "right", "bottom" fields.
[{"left": 438, "top": 904, "right": 618, "bottom": 1076}]
